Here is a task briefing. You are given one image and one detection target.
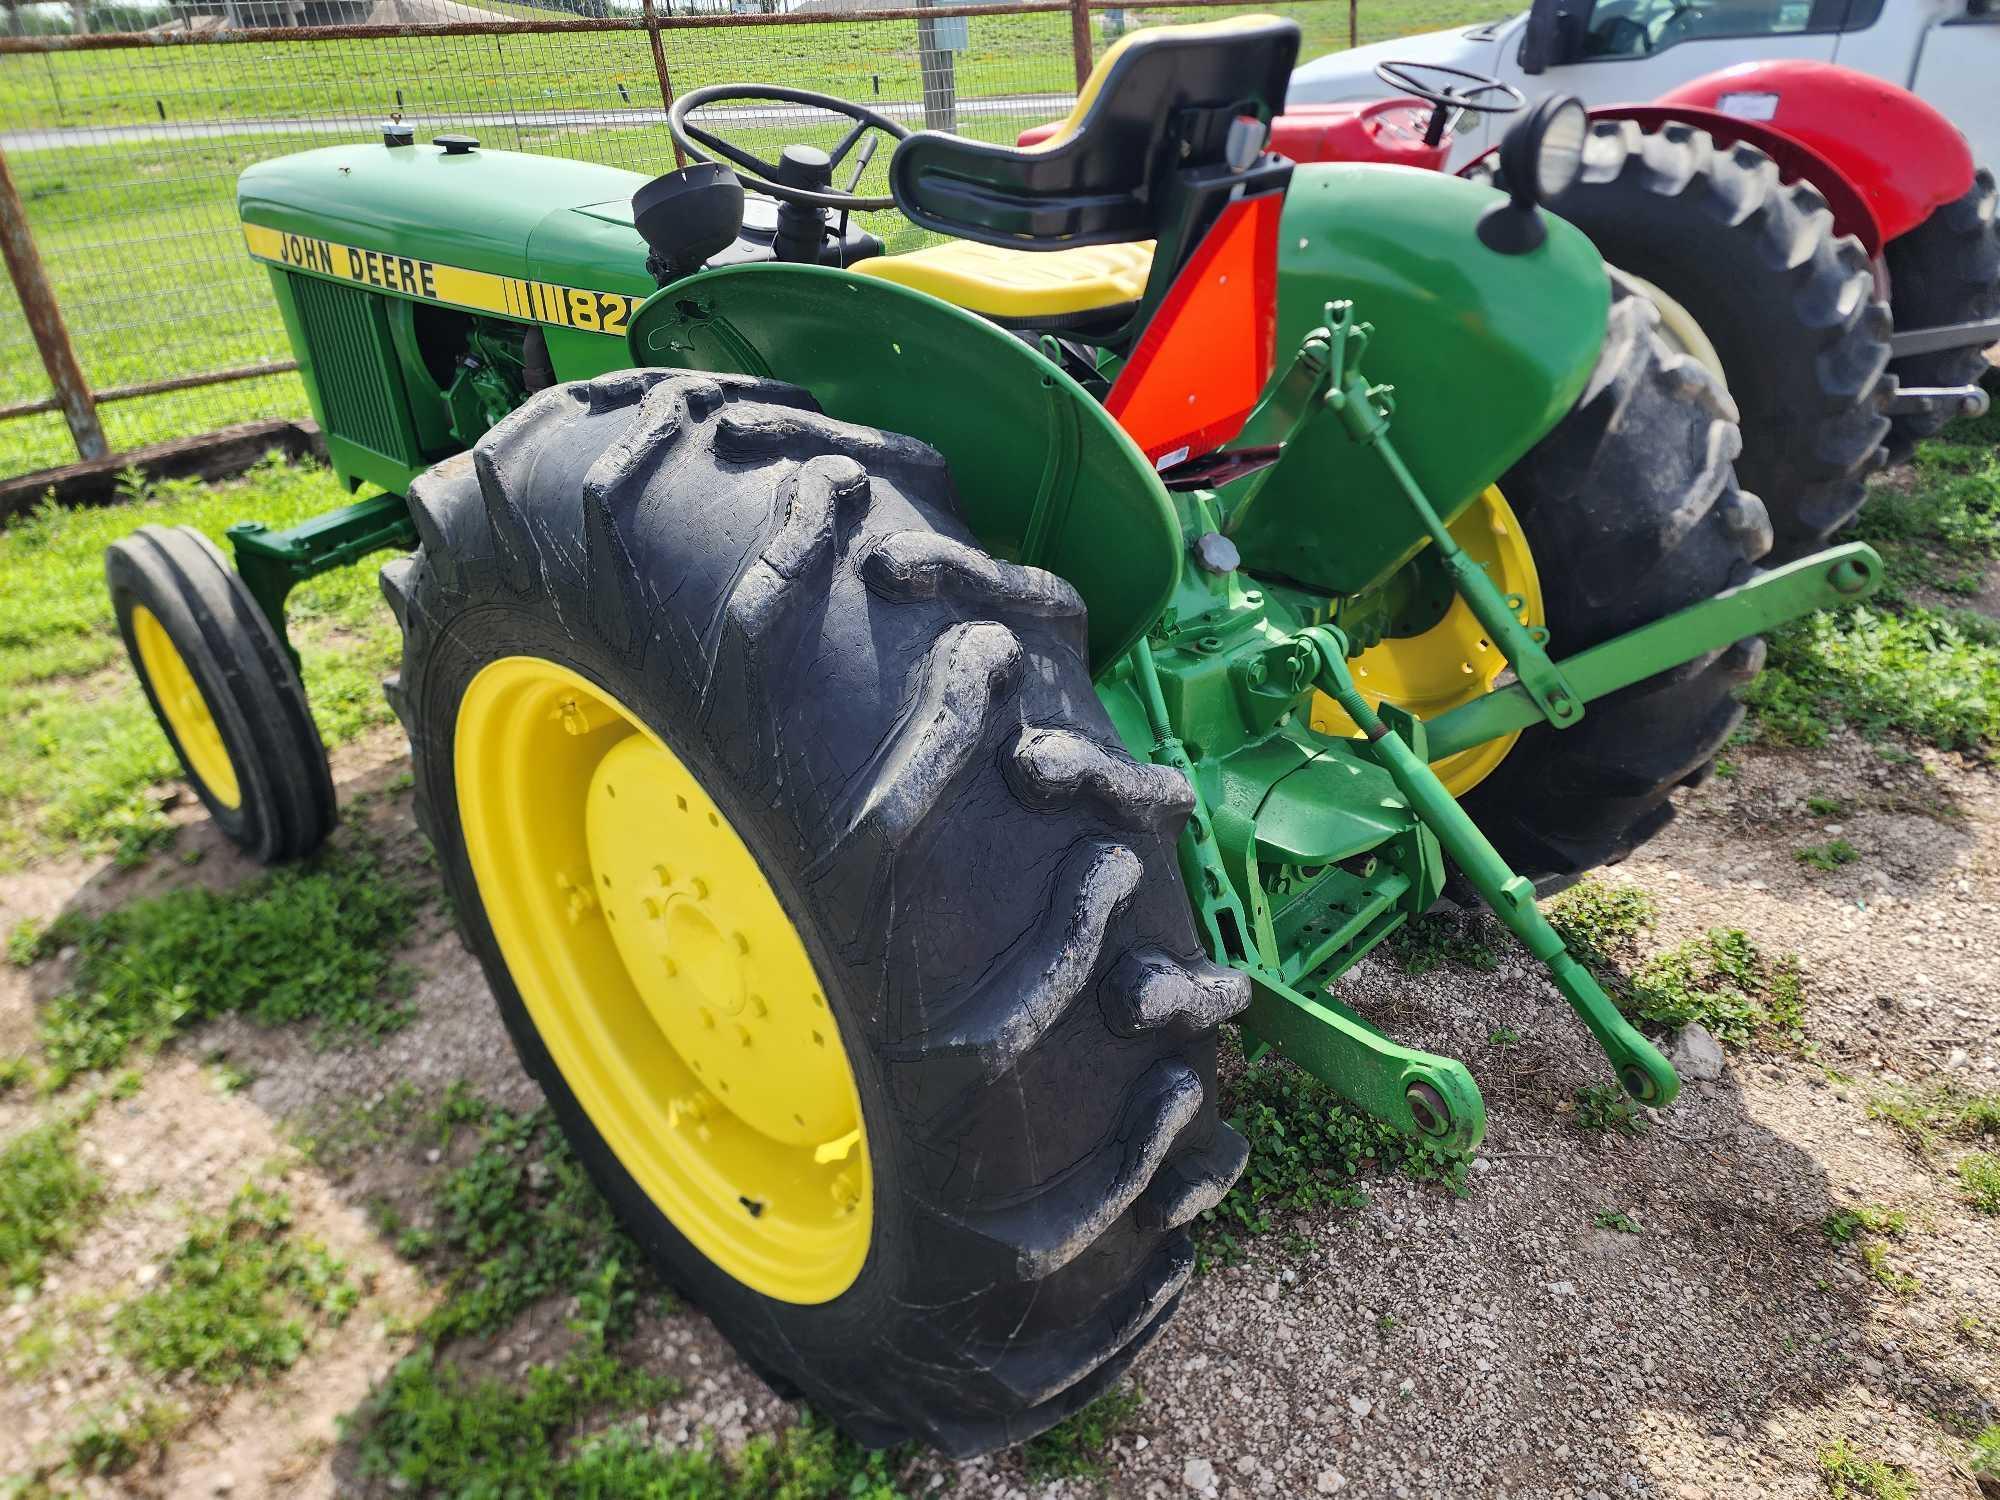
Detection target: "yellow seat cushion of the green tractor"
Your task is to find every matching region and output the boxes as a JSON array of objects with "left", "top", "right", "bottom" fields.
[{"left": 848, "top": 240, "right": 1152, "bottom": 318}]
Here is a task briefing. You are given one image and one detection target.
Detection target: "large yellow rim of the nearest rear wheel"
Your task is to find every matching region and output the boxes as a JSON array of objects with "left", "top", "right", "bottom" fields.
[{"left": 454, "top": 656, "right": 872, "bottom": 1302}]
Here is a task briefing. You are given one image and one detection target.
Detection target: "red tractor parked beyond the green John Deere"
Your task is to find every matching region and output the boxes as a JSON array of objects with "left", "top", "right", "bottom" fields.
[{"left": 1020, "top": 60, "right": 2000, "bottom": 562}]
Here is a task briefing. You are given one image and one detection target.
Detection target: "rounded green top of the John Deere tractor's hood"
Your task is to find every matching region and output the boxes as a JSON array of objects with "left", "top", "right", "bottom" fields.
[{"left": 236, "top": 144, "right": 654, "bottom": 296}]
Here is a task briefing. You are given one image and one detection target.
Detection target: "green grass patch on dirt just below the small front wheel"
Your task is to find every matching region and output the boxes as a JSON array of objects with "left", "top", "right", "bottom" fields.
[{"left": 20, "top": 844, "right": 422, "bottom": 1088}]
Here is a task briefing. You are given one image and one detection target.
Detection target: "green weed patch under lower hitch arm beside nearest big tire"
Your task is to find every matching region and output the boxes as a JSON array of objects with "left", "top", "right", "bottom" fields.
[{"left": 1196, "top": 1058, "right": 1466, "bottom": 1268}]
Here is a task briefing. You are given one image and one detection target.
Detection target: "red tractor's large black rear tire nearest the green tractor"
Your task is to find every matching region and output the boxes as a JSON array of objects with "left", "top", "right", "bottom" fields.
[{"left": 1468, "top": 120, "right": 1892, "bottom": 564}]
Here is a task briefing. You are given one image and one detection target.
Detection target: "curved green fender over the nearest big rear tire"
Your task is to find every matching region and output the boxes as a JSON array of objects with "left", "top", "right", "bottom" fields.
[{"left": 630, "top": 262, "right": 1182, "bottom": 672}]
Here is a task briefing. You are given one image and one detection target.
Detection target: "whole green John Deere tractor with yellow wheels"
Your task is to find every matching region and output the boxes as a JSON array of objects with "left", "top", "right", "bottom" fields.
[{"left": 108, "top": 18, "right": 1880, "bottom": 1454}]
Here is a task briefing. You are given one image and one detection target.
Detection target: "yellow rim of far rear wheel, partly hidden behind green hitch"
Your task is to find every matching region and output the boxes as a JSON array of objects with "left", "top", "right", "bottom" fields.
[{"left": 1312, "top": 486, "right": 1546, "bottom": 796}]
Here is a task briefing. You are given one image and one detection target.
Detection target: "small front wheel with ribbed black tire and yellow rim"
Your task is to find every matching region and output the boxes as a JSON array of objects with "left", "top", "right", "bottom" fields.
[{"left": 104, "top": 526, "right": 336, "bottom": 864}]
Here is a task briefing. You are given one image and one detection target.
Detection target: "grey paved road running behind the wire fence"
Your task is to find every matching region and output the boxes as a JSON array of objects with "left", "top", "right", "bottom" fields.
[{"left": 0, "top": 94, "right": 1074, "bottom": 154}]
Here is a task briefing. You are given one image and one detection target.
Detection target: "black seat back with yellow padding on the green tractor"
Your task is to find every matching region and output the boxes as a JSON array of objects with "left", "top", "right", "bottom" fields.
[{"left": 890, "top": 16, "right": 1298, "bottom": 250}]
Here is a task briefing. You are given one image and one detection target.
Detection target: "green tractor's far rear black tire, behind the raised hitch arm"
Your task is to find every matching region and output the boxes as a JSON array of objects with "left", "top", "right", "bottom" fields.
[{"left": 1462, "top": 286, "right": 1772, "bottom": 890}]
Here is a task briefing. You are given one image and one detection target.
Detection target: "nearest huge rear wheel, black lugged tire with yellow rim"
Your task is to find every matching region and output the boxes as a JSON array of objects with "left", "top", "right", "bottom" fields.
[{"left": 382, "top": 370, "right": 1248, "bottom": 1454}]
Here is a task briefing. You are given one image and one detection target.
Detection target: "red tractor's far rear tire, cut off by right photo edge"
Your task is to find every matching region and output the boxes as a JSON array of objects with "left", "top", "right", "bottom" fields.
[{"left": 1882, "top": 168, "right": 2000, "bottom": 458}]
